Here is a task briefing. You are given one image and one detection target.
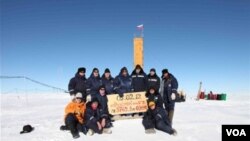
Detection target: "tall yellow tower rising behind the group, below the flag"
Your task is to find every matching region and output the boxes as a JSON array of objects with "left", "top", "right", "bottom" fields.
[{"left": 134, "top": 37, "right": 144, "bottom": 68}]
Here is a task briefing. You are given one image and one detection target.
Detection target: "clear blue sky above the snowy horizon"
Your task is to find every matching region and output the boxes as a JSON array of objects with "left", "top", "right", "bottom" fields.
[{"left": 1, "top": 0, "right": 250, "bottom": 94}]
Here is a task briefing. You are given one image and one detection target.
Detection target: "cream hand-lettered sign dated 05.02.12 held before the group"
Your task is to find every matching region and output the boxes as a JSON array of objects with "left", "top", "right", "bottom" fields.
[{"left": 107, "top": 92, "right": 148, "bottom": 115}]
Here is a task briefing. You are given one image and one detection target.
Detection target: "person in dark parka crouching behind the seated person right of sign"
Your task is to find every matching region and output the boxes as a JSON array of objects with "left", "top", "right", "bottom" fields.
[{"left": 145, "top": 86, "right": 163, "bottom": 108}]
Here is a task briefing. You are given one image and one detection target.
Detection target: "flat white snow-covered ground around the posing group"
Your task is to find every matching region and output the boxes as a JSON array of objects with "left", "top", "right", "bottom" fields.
[{"left": 1, "top": 93, "right": 250, "bottom": 141}]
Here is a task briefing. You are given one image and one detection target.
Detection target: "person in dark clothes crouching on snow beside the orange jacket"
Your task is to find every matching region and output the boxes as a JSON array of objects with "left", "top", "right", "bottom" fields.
[{"left": 85, "top": 98, "right": 112, "bottom": 136}]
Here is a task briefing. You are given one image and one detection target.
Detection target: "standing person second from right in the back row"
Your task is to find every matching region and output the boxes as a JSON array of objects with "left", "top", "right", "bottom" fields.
[{"left": 147, "top": 68, "right": 161, "bottom": 92}]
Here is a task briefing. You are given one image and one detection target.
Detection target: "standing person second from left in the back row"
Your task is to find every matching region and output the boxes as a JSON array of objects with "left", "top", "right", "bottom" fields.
[{"left": 87, "top": 68, "right": 102, "bottom": 95}]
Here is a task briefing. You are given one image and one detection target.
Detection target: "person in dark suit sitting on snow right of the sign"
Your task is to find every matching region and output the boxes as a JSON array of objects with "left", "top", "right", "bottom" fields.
[{"left": 142, "top": 101, "right": 177, "bottom": 135}]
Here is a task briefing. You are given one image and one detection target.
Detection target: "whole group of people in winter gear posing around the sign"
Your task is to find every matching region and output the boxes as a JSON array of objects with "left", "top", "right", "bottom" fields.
[{"left": 61, "top": 65, "right": 178, "bottom": 138}]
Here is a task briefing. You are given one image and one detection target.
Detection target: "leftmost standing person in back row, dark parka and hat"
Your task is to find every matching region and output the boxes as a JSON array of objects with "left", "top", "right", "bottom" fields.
[{"left": 68, "top": 67, "right": 87, "bottom": 102}]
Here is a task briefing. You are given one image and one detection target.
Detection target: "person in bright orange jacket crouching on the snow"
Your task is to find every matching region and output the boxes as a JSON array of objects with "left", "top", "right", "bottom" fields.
[{"left": 60, "top": 93, "right": 87, "bottom": 139}]
